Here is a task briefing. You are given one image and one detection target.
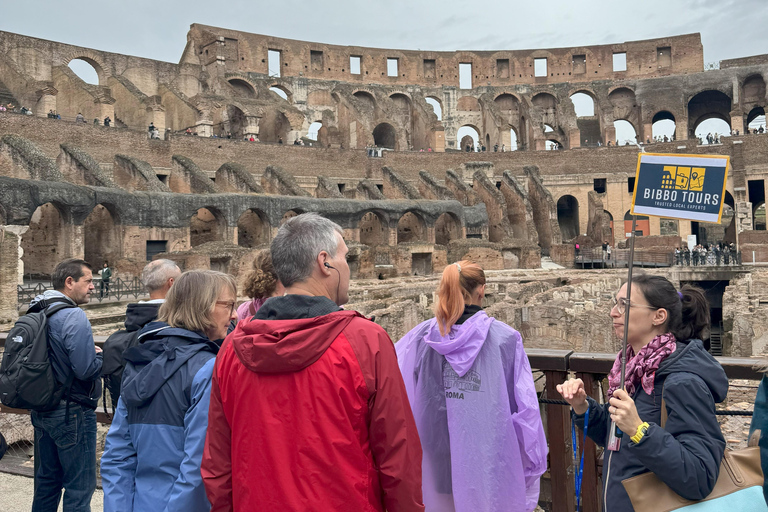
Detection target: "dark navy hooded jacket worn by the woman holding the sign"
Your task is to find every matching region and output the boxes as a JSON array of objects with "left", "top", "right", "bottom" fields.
[{"left": 571, "top": 340, "right": 728, "bottom": 512}]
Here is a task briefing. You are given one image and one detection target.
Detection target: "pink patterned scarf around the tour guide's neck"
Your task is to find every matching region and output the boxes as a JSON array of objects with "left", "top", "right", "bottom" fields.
[{"left": 608, "top": 332, "right": 677, "bottom": 399}]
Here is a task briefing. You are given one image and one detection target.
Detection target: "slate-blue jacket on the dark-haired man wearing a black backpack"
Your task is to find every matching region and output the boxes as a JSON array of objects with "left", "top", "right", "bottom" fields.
[{"left": 29, "top": 290, "right": 102, "bottom": 409}]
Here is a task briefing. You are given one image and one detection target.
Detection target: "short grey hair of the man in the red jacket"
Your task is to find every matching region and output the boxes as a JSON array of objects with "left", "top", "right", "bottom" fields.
[{"left": 270, "top": 213, "right": 344, "bottom": 288}]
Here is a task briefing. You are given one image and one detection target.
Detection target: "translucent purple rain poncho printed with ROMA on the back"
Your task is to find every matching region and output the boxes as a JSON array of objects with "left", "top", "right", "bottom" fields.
[{"left": 395, "top": 311, "right": 547, "bottom": 512}]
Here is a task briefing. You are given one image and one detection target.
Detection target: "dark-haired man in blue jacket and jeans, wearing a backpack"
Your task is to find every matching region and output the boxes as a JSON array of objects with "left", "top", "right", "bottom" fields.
[{"left": 28, "top": 259, "right": 102, "bottom": 512}]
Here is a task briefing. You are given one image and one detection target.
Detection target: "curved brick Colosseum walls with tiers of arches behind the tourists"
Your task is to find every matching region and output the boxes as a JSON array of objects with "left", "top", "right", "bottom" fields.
[{"left": 0, "top": 24, "right": 768, "bottom": 354}]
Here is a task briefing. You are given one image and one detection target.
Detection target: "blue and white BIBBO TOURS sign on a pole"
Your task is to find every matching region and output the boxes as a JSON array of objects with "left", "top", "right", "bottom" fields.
[{"left": 632, "top": 153, "right": 729, "bottom": 222}]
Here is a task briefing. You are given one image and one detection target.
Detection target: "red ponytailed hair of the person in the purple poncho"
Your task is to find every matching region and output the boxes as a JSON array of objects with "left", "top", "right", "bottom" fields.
[{"left": 435, "top": 260, "right": 485, "bottom": 336}]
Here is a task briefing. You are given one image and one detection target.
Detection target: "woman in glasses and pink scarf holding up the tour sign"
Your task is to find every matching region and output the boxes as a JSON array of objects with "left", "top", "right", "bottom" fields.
[{"left": 557, "top": 275, "right": 728, "bottom": 512}]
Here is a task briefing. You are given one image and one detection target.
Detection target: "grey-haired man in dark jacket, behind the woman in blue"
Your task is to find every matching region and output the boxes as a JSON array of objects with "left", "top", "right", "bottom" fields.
[{"left": 101, "top": 260, "right": 181, "bottom": 412}]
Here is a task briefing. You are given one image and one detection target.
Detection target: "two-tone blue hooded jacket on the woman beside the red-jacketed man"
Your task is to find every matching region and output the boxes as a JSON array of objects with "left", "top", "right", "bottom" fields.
[{"left": 101, "top": 322, "right": 219, "bottom": 512}]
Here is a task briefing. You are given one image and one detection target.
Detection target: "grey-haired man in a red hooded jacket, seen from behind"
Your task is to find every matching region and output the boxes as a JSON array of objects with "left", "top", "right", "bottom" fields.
[{"left": 202, "top": 213, "right": 424, "bottom": 512}]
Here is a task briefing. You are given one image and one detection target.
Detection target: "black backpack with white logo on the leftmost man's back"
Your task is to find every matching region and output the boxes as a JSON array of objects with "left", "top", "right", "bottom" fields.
[{"left": 0, "top": 299, "right": 77, "bottom": 411}]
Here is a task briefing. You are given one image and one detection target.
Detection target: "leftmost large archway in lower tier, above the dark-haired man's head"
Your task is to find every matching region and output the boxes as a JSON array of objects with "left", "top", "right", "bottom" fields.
[{"left": 21, "top": 202, "right": 72, "bottom": 278}]
